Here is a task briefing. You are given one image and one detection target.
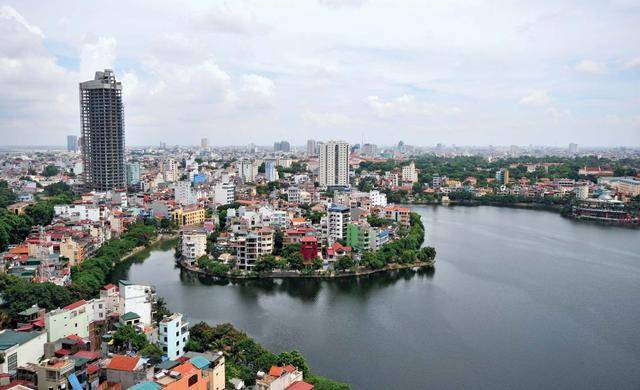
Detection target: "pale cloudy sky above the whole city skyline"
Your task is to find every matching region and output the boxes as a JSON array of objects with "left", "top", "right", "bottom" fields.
[{"left": 0, "top": 0, "right": 640, "bottom": 146}]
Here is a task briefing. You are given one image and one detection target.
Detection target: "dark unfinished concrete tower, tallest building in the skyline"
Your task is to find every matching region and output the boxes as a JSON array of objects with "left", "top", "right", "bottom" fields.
[{"left": 80, "top": 69, "right": 126, "bottom": 191}]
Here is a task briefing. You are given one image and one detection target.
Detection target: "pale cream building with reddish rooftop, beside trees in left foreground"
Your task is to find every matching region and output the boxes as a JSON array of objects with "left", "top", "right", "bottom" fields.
[{"left": 44, "top": 300, "right": 93, "bottom": 342}]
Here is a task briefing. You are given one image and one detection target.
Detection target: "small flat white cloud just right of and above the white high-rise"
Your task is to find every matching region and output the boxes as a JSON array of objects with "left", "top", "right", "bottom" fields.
[{"left": 366, "top": 95, "right": 462, "bottom": 118}]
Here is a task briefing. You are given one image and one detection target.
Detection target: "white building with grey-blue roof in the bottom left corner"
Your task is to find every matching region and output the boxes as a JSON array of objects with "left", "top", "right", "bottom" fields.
[{"left": 0, "top": 330, "right": 47, "bottom": 374}]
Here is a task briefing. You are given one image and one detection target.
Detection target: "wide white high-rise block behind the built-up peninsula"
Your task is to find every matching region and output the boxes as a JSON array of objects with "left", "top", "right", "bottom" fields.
[{"left": 318, "top": 141, "right": 349, "bottom": 188}]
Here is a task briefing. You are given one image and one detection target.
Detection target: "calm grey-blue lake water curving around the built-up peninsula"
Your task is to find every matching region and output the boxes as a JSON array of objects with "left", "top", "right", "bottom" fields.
[{"left": 116, "top": 206, "right": 640, "bottom": 389}]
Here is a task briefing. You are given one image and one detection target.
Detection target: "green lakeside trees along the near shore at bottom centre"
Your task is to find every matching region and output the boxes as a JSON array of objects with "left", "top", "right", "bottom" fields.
[{"left": 187, "top": 322, "right": 350, "bottom": 390}]
